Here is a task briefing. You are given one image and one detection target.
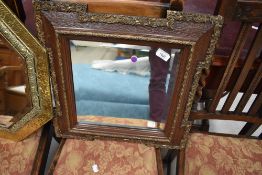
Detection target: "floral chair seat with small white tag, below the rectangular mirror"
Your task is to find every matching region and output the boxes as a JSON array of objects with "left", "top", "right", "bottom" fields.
[{"left": 53, "top": 139, "right": 158, "bottom": 175}]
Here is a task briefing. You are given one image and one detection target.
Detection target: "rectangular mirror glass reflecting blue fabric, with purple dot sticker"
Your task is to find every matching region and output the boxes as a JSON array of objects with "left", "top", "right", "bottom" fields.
[{"left": 70, "top": 40, "right": 179, "bottom": 129}]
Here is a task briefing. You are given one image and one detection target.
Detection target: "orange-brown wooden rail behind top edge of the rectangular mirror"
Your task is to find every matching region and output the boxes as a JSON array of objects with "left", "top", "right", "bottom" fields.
[{"left": 52, "top": 0, "right": 184, "bottom": 18}]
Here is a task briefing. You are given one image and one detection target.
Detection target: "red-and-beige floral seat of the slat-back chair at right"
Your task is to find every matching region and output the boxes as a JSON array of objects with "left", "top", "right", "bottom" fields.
[{"left": 185, "top": 133, "right": 262, "bottom": 175}]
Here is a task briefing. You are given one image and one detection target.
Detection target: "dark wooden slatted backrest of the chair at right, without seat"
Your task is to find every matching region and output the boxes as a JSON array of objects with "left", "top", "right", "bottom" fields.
[{"left": 203, "top": 0, "right": 262, "bottom": 135}]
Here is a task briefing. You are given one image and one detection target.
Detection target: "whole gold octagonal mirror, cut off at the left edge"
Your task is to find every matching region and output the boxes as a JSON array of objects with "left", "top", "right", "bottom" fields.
[{"left": 0, "top": 1, "right": 52, "bottom": 141}]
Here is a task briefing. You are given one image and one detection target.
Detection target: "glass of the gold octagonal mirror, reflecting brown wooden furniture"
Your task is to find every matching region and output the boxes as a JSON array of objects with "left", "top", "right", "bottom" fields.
[{"left": 0, "top": 35, "right": 32, "bottom": 128}]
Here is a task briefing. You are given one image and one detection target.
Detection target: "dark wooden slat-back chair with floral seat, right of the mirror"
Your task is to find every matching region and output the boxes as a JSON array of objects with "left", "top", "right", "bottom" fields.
[{"left": 169, "top": 0, "right": 262, "bottom": 175}]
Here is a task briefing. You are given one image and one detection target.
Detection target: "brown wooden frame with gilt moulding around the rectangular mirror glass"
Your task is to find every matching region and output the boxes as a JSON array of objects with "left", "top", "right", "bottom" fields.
[{"left": 34, "top": 1, "right": 223, "bottom": 149}]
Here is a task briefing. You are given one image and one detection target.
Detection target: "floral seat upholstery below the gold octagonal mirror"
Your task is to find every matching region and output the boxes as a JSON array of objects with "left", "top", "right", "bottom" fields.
[{"left": 0, "top": 130, "right": 42, "bottom": 175}]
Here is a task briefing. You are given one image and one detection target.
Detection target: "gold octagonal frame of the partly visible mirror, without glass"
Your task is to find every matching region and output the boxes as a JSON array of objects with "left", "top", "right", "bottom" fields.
[{"left": 0, "top": 0, "right": 53, "bottom": 141}]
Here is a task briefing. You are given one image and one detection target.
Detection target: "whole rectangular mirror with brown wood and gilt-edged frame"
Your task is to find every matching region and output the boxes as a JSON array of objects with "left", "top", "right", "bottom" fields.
[{"left": 35, "top": 1, "right": 223, "bottom": 148}]
